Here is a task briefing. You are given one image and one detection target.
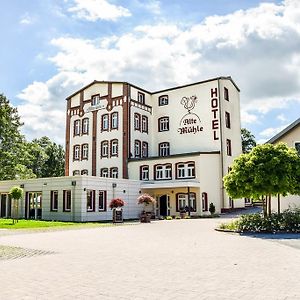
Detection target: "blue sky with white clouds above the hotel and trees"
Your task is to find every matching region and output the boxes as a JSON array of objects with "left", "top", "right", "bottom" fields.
[{"left": 0, "top": 0, "right": 300, "bottom": 145}]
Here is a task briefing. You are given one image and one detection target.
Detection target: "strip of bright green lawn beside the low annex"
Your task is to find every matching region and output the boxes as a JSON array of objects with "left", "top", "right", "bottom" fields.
[{"left": 0, "top": 219, "right": 127, "bottom": 229}]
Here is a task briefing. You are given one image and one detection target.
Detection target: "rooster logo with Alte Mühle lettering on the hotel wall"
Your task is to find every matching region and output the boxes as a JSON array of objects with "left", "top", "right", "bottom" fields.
[{"left": 178, "top": 95, "right": 203, "bottom": 134}]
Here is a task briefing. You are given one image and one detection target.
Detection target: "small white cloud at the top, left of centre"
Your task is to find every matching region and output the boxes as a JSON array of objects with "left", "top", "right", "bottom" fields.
[{"left": 69, "top": 0, "right": 131, "bottom": 22}]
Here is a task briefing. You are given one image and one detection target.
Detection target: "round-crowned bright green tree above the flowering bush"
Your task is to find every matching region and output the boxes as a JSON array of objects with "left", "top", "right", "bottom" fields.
[{"left": 223, "top": 143, "right": 300, "bottom": 214}]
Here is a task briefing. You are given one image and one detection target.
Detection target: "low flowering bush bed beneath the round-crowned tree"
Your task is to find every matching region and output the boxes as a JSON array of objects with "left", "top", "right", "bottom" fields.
[{"left": 220, "top": 208, "right": 300, "bottom": 233}]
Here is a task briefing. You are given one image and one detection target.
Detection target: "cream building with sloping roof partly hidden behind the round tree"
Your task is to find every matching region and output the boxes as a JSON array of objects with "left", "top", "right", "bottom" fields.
[{"left": 267, "top": 118, "right": 300, "bottom": 211}]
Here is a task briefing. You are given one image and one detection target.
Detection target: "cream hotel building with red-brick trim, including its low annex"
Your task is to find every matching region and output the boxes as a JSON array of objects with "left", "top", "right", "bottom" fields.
[{"left": 0, "top": 77, "right": 245, "bottom": 221}]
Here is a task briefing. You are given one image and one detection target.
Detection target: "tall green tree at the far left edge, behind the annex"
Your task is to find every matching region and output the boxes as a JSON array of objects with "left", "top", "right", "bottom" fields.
[{"left": 0, "top": 94, "right": 34, "bottom": 180}]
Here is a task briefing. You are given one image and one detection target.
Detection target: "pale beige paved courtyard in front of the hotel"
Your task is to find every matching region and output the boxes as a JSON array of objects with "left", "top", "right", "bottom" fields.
[{"left": 0, "top": 219, "right": 300, "bottom": 300}]
